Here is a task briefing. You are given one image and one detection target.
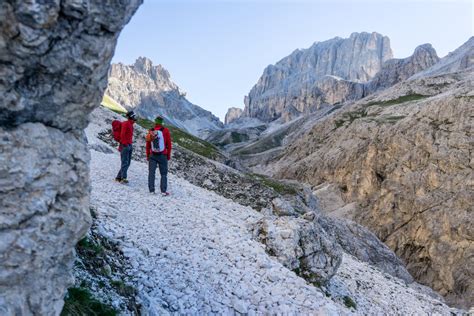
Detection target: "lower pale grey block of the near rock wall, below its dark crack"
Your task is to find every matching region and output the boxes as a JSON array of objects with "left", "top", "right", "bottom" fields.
[{"left": 0, "top": 123, "right": 91, "bottom": 315}]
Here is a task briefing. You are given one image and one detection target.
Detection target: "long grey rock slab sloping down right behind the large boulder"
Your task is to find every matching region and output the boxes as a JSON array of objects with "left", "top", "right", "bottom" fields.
[{"left": 317, "top": 216, "right": 413, "bottom": 283}]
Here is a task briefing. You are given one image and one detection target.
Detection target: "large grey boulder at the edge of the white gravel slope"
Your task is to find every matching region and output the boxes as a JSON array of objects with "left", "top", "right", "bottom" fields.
[{"left": 255, "top": 217, "right": 342, "bottom": 284}]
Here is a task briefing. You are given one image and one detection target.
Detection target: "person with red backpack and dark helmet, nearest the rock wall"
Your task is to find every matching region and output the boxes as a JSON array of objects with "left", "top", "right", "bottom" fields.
[{"left": 115, "top": 111, "right": 137, "bottom": 183}]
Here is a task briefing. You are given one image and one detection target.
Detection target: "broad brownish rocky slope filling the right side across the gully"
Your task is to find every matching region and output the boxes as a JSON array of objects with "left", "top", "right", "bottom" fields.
[{"left": 266, "top": 52, "right": 474, "bottom": 308}]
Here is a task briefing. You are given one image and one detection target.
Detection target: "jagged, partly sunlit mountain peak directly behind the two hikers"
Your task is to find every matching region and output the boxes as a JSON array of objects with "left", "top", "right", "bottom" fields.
[{"left": 106, "top": 57, "right": 223, "bottom": 136}]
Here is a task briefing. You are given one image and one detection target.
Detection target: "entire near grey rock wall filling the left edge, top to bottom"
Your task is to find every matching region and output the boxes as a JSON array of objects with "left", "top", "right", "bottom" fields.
[{"left": 0, "top": 0, "right": 141, "bottom": 315}]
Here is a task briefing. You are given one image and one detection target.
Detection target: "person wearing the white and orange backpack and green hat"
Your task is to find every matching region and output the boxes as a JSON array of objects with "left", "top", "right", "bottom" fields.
[{"left": 146, "top": 115, "right": 172, "bottom": 196}]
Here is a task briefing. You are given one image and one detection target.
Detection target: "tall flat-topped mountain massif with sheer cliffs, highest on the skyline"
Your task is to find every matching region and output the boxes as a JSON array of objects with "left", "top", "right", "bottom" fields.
[{"left": 241, "top": 32, "right": 392, "bottom": 122}]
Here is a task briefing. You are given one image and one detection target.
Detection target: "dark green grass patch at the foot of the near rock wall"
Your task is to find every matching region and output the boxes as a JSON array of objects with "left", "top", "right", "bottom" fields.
[{"left": 61, "top": 287, "right": 118, "bottom": 316}]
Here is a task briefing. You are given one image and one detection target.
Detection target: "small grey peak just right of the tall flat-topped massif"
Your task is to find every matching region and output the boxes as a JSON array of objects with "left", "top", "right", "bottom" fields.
[{"left": 366, "top": 44, "right": 439, "bottom": 94}]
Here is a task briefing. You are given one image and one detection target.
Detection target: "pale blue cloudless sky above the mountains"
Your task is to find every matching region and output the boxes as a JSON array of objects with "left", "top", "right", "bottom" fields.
[{"left": 113, "top": 0, "right": 474, "bottom": 120}]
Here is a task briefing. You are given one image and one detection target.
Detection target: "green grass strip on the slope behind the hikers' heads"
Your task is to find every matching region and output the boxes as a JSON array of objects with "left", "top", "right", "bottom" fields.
[{"left": 137, "top": 118, "right": 224, "bottom": 160}]
